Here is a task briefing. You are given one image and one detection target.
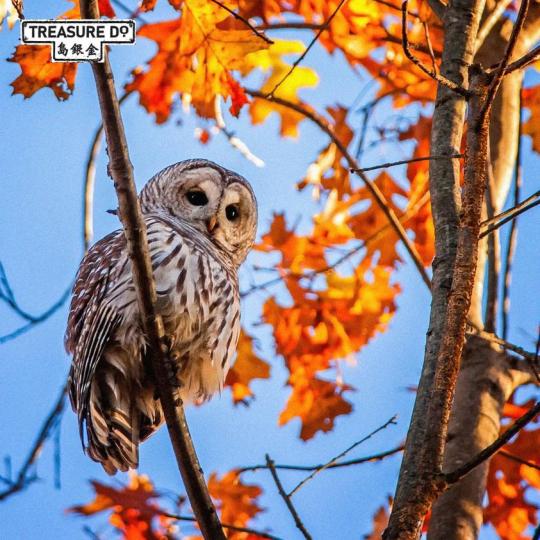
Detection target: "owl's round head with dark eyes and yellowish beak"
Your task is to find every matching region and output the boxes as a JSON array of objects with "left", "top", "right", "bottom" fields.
[{"left": 139, "top": 159, "right": 257, "bottom": 266}]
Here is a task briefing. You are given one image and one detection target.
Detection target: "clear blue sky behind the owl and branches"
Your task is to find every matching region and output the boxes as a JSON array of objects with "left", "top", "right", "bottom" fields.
[{"left": 0, "top": 0, "right": 540, "bottom": 540}]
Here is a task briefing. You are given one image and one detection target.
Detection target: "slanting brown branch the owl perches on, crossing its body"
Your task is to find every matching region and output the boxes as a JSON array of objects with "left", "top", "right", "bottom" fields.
[{"left": 81, "top": 0, "right": 225, "bottom": 540}]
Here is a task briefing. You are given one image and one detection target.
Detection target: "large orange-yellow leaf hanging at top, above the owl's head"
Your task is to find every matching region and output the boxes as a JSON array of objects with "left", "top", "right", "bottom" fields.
[{"left": 126, "top": 0, "right": 268, "bottom": 123}]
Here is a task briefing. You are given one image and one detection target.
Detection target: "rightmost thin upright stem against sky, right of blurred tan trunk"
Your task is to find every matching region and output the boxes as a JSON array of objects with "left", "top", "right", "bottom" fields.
[{"left": 502, "top": 94, "right": 523, "bottom": 339}]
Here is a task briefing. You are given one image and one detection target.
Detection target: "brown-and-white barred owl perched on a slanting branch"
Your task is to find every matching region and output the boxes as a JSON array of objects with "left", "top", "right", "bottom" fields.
[{"left": 65, "top": 159, "right": 257, "bottom": 474}]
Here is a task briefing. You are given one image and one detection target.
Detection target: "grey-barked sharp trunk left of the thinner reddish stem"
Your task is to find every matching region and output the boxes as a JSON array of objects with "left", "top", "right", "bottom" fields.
[{"left": 384, "top": 0, "right": 484, "bottom": 540}]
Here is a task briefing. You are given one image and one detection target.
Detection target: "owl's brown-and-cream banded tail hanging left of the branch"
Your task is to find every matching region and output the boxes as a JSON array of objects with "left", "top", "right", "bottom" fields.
[{"left": 86, "top": 350, "right": 163, "bottom": 475}]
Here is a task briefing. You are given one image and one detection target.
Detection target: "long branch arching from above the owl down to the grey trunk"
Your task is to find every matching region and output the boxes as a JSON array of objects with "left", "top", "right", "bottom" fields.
[{"left": 246, "top": 89, "right": 431, "bottom": 288}]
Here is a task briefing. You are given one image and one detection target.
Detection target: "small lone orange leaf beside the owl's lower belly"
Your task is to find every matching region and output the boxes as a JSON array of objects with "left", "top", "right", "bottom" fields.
[{"left": 225, "top": 330, "right": 270, "bottom": 404}]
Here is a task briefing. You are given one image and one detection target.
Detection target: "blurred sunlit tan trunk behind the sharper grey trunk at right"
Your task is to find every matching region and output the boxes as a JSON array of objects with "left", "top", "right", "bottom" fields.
[{"left": 428, "top": 5, "right": 540, "bottom": 540}]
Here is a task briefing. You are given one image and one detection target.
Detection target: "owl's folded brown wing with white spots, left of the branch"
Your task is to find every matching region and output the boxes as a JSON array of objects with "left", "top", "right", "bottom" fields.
[{"left": 65, "top": 231, "right": 126, "bottom": 422}]
